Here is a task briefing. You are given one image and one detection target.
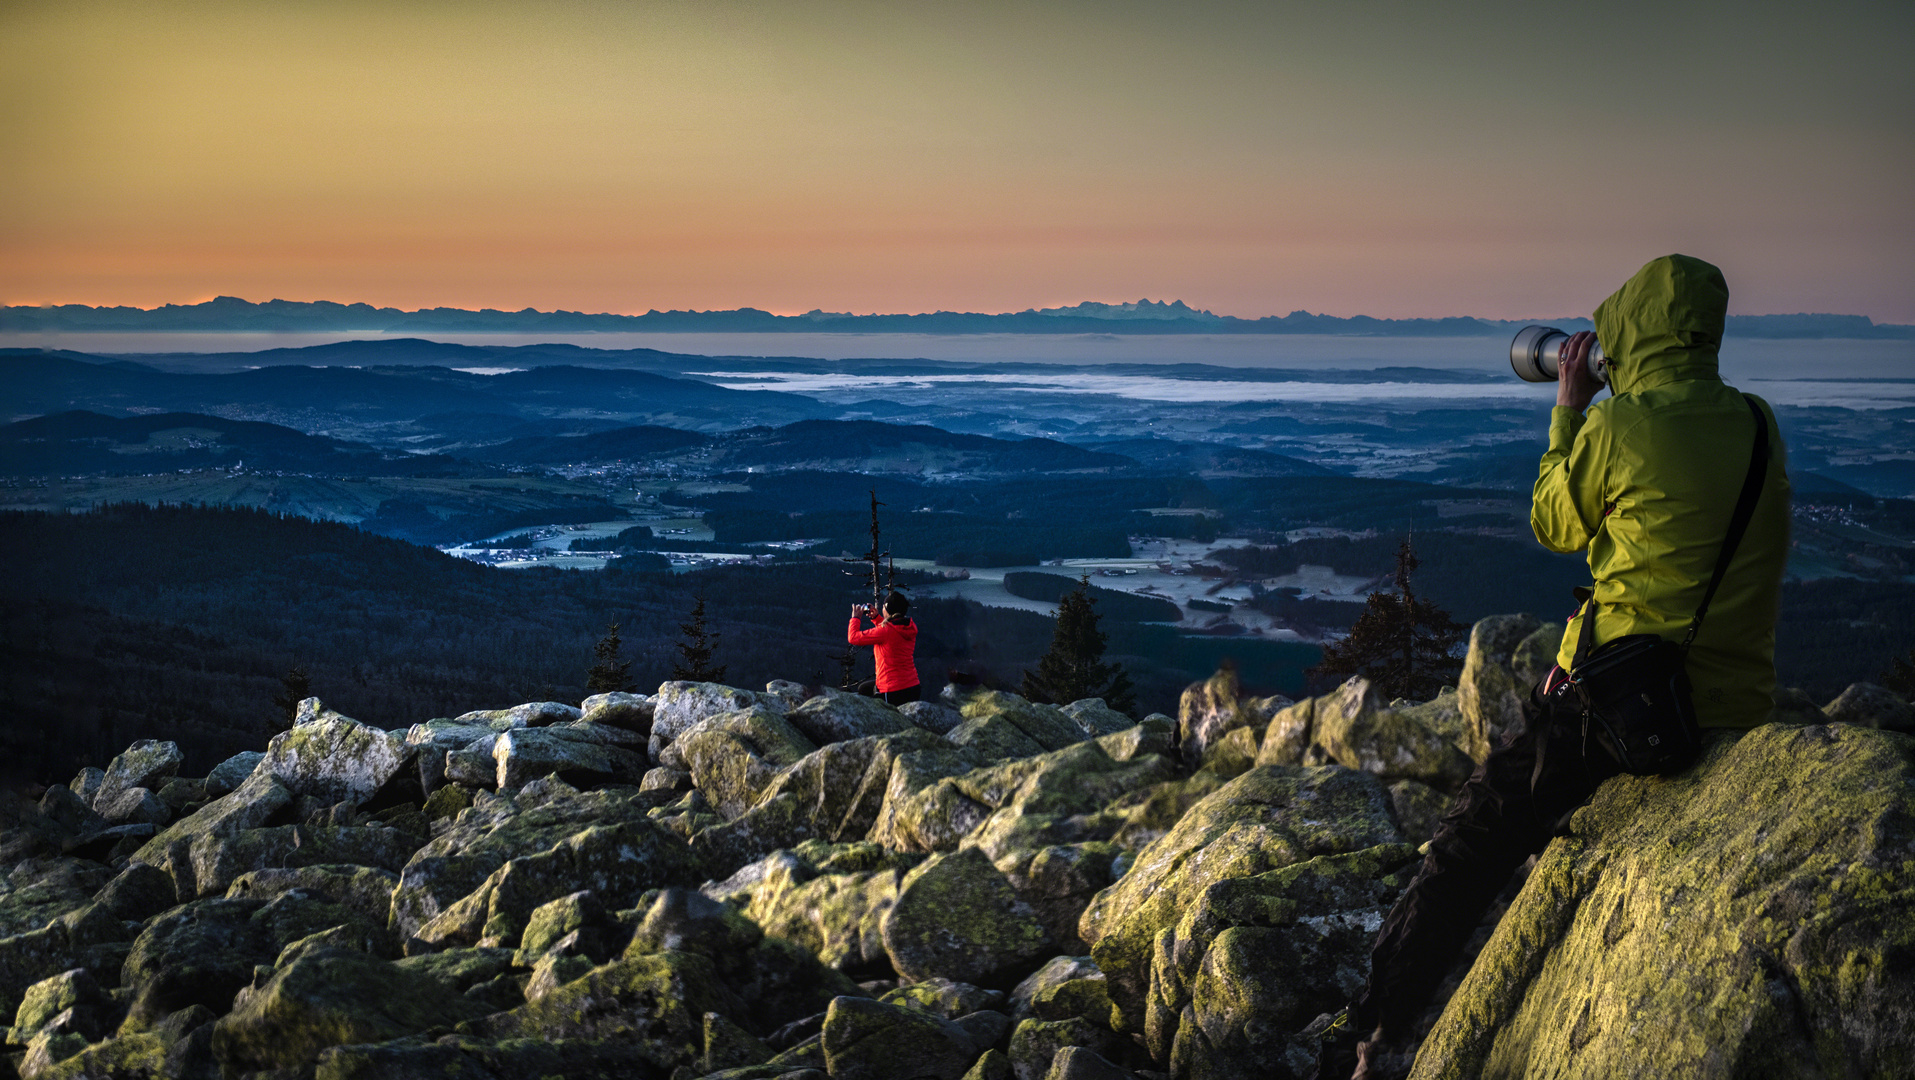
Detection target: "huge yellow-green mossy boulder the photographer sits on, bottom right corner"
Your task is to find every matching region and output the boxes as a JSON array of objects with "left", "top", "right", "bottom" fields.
[{"left": 1411, "top": 724, "right": 1915, "bottom": 1080}]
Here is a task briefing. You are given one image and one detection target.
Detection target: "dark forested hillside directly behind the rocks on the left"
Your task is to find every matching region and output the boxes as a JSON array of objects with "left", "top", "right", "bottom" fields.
[{"left": 0, "top": 506, "right": 1316, "bottom": 772}]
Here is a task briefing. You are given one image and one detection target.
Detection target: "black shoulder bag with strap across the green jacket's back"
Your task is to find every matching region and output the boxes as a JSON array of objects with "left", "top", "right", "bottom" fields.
[{"left": 1570, "top": 394, "right": 1769, "bottom": 776}]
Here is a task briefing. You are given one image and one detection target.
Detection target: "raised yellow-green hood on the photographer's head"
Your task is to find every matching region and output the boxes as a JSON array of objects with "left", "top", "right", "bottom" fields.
[{"left": 1595, "top": 255, "right": 1729, "bottom": 394}]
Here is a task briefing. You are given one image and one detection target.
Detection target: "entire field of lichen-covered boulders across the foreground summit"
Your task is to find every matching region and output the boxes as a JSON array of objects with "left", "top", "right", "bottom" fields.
[{"left": 0, "top": 617, "right": 1915, "bottom": 1080}]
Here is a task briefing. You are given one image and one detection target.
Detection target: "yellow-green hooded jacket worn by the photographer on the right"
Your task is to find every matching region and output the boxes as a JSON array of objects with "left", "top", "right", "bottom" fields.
[{"left": 1530, "top": 255, "right": 1789, "bottom": 728}]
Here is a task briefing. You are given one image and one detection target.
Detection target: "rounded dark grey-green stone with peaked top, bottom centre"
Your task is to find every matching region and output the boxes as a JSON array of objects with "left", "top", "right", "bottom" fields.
[{"left": 883, "top": 850, "right": 1053, "bottom": 986}]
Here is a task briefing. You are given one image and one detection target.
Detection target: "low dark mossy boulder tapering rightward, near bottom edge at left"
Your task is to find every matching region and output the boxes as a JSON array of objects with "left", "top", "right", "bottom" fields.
[{"left": 213, "top": 948, "right": 486, "bottom": 1074}]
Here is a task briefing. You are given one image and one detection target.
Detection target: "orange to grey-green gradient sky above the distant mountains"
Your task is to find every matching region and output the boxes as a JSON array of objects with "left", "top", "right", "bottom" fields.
[{"left": 0, "top": 0, "right": 1915, "bottom": 324}]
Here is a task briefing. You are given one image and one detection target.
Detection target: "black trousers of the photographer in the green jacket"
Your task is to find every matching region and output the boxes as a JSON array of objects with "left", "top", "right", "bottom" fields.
[{"left": 1356, "top": 684, "right": 1622, "bottom": 1038}]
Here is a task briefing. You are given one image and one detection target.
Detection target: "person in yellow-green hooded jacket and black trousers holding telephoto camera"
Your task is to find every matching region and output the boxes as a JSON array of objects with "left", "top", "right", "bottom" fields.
[{"left": 1318, "top": 255, "right": 1789, "bottom": 1080}]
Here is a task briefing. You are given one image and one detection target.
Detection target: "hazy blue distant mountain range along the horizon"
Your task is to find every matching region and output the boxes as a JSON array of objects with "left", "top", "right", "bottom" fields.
[{"left": 0, "top": 297, "right": 1915, "bottom": 339}]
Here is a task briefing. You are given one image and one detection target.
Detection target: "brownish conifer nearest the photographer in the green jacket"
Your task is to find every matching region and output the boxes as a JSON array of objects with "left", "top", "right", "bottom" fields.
[{"left": 1310, "top": 536, "right": 1469, "bottom": 701}]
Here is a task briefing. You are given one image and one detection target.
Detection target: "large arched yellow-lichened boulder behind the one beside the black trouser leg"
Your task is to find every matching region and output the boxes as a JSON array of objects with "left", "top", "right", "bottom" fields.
[{"left": 1078, "top": 766, "right": 1400, "bottom": 1030}]
